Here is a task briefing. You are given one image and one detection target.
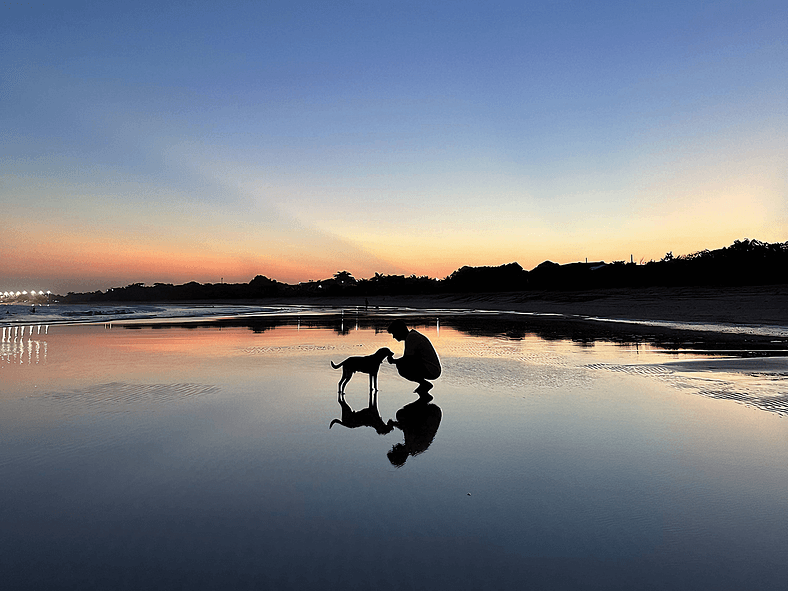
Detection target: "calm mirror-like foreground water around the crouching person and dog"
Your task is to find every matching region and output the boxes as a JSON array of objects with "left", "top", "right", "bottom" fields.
[{"left": 0, "top": 314, "right": 788, "bottom": 590}]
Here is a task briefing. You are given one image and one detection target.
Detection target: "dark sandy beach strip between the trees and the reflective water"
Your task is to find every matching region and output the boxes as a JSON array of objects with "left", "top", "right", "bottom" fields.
[{"left": 7, "top": 284, "right": 788, "bottom": 350}]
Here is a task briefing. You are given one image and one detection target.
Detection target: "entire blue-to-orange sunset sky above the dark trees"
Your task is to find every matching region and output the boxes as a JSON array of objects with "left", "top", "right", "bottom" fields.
[{"left": 0, "top": 0, "right": 788, "bottom": 293}]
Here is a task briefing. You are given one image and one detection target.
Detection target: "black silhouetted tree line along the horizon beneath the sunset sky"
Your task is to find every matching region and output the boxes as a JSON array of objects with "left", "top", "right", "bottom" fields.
[{"left": 60, "top": 240, "right": 788, "bottom": 302}]
